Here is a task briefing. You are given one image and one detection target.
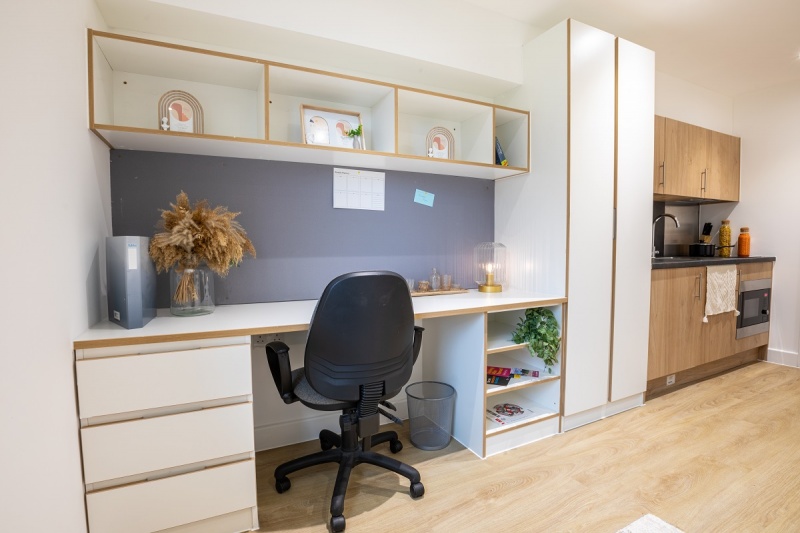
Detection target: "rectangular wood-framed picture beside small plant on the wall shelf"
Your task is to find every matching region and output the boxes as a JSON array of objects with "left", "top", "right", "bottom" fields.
[{"left": 300, "top": 104, "right": 367, "bottom": 150}]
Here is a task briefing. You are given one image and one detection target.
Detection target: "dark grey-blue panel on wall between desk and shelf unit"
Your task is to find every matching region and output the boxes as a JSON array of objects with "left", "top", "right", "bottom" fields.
[{"left": 111, "top": 150, "right": 494, "bottom": 308}]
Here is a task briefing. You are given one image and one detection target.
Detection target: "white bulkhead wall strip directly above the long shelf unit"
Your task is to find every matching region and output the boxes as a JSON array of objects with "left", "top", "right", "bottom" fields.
[{"left": 140, "top": 0, "right": 531, "bottom": 88}]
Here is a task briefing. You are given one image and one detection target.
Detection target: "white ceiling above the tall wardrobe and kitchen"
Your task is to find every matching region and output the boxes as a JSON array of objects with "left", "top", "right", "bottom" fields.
[{"left": 463, "top": 0, "right": 800, "bottom": 96}]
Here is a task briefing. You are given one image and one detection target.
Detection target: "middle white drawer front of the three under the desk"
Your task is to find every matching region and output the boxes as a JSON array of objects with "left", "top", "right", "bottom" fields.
[{"left": 81, "top": 403, "right": 254, "bottom": 484}]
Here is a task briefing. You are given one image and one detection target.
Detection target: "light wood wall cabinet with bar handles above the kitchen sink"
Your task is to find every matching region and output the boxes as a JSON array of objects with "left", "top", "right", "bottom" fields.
[{"left": 653, "top": 116, "right": 741, "bottom": 202}]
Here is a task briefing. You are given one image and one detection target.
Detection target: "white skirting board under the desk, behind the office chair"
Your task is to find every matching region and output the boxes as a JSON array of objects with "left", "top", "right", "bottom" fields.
[{"left": 255, "top": 397, "right": 408, "bottom": 452}]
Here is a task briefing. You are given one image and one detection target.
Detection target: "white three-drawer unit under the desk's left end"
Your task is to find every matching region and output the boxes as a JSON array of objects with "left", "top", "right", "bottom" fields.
[{"left": 76, "top": 337, "right": 258, "bottom": 533}]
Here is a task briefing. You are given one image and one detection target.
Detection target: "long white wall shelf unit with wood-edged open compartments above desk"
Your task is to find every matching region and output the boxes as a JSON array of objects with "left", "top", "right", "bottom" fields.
[{"left": 88, "top": 29, "right": 530, "bottom": 180}]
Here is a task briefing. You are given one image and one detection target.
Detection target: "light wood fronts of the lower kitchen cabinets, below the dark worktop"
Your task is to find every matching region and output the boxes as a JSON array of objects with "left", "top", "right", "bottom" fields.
[{"left": 647, "top": 262, "right": 772, "bottom": 381}]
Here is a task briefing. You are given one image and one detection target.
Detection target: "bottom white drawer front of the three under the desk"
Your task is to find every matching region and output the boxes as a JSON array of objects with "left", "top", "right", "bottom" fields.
[{"left": 86, "top": 460, "right": 256, "bottom": 533}]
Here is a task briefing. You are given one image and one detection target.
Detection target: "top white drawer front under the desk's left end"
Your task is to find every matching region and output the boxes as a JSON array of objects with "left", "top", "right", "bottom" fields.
[{"left": 75, "top": 344, "right": 252, "bottom": 418}]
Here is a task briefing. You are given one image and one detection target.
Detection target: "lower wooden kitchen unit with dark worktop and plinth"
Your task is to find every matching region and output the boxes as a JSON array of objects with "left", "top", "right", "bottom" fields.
[{"left": 647, "top": 257, "right": 775, "bottom": 398}]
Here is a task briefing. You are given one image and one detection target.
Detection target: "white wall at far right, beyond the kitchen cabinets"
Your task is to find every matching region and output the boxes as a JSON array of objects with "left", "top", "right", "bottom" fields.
[{"left": 731, "top": 82, "right": 800, "bottom": 366}]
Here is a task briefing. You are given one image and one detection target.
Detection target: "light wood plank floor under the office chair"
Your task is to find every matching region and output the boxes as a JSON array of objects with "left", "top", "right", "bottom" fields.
[{"left": 257, "top": 363, "right": 800, "bottom": 533}]
